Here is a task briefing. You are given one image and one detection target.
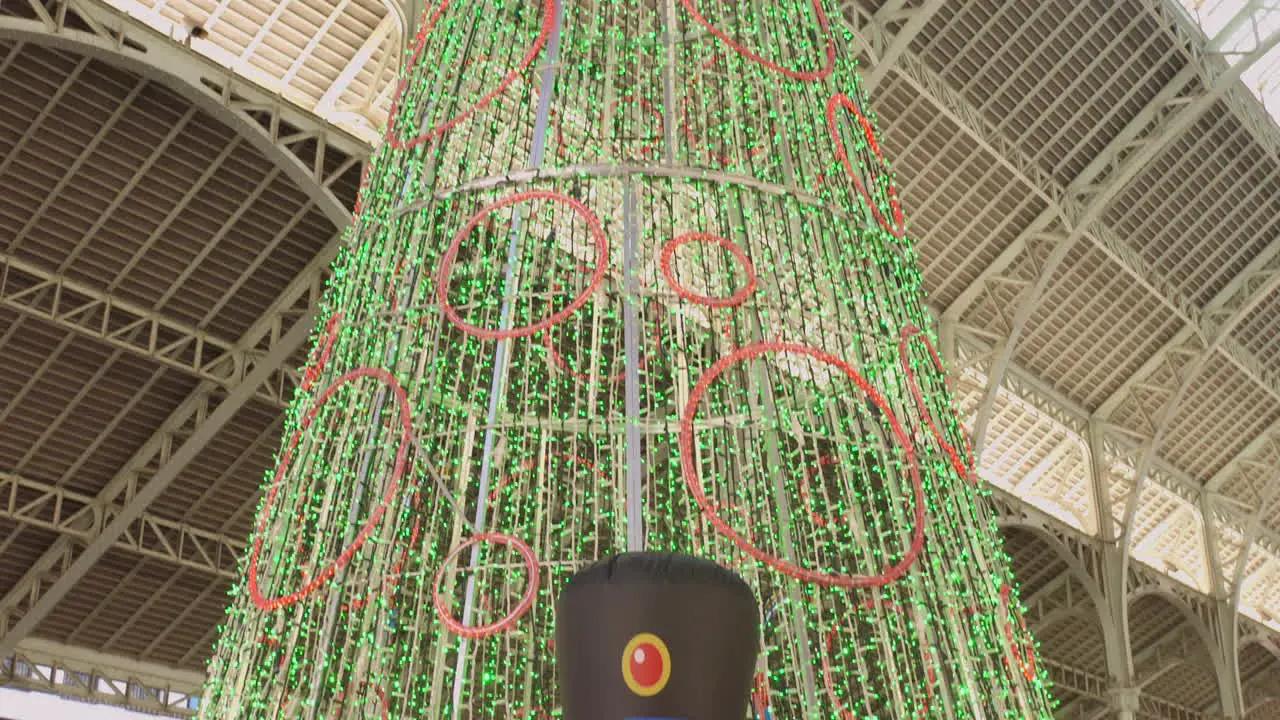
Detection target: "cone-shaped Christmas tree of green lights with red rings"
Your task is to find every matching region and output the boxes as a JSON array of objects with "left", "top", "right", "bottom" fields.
[{"left": 201, "top": 0, "right": 1051, "bottom": 720}]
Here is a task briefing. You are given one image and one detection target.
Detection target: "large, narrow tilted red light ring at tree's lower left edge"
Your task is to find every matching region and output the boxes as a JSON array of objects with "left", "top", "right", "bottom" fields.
[{"left": 248, "top": 368, "right": 413, "bottom": 610}]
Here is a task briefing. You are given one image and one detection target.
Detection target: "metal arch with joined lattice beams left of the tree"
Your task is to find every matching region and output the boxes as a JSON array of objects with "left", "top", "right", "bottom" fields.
[{"left": 0, "top": 0, "right": 355, "bottom": 673}]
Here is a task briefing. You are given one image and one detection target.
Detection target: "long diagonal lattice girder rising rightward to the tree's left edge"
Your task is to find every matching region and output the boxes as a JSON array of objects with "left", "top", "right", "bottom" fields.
[{"left": 0, "top": 236, "right": 339, "bottom": 656}]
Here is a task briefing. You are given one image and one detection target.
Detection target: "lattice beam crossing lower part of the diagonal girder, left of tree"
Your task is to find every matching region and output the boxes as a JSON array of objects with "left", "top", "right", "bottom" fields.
[{"left": 0, "top": 471, "right": 244, "bottom": 578}]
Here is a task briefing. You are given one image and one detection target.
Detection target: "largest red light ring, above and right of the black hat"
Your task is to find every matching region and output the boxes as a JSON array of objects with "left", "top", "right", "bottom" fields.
[{"left": 680, "top": 342, "right": 924, "bottom": 588}]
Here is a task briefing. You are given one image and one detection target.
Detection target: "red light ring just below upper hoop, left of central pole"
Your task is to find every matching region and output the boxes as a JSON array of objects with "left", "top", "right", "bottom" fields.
[{"left": 435, "top": 190, "right": 609, "bottom": 340}]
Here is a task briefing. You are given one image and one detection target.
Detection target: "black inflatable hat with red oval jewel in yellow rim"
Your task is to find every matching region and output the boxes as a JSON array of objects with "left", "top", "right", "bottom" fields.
[{"left": 556, "top": 552, "right": 760, "bottom": 720}]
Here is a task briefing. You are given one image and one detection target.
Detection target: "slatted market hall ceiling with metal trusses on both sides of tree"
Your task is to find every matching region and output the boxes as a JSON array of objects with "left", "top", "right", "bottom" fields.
[{"left": 0, "top": 0, "right": 1280, "bottom": 717}]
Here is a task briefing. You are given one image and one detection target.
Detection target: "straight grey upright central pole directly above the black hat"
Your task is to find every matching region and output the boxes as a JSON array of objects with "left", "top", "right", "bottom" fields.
[{"left": 622, "top": 179, "right": 644, "bottom": 551}]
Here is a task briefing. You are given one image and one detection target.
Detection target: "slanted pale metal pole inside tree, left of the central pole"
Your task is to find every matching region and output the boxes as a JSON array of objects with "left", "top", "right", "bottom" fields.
[{"left": 453, "top": 0, "right": 564, "bottom": 720}]
